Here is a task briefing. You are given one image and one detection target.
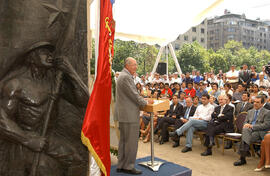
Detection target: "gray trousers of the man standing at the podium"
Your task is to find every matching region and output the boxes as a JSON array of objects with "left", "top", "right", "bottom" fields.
[{"left": 117, "top": 122, "right": 140, "bottom": 170}]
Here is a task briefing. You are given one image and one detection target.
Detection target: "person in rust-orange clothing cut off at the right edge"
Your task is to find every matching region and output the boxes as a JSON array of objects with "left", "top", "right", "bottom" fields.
[{"left": 254, "top": 131, "right": 270, "bottom": 172}]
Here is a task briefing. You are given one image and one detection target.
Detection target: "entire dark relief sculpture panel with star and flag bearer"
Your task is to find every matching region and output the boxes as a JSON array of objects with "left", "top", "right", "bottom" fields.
[{"left": 0, "top": 0, "right": 89, "bottom": 176}]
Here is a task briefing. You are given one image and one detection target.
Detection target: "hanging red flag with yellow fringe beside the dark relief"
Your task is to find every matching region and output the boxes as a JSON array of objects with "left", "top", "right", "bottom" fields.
[{"left": 81, "top": 0, "right": 115, "bottom": 176}]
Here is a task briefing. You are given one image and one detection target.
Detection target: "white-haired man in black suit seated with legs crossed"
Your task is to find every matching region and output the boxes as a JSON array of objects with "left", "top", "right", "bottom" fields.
[{"left": 201, "top": 94, "right": 233, "bottom": 156}]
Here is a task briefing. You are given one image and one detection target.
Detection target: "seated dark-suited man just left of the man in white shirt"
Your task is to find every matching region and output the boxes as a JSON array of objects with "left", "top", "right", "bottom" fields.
[{"left": 173, "top": 97, "right": 196, "bottom": 147}]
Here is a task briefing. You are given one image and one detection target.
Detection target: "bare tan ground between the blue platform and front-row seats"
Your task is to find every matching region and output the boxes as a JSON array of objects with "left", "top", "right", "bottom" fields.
[{"left": 112, "top": 137, "right": 270, "bottom": 176}]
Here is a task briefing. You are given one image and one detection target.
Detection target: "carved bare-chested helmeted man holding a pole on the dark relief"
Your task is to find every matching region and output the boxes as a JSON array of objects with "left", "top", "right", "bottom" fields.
[{"left": 0, "top": 41, "right": 89, "bottom": 176}]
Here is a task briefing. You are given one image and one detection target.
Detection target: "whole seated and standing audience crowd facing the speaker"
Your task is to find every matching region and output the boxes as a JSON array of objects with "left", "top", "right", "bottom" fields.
[{"left": 115, "top": 64, "right": 270, "bottom": 171}]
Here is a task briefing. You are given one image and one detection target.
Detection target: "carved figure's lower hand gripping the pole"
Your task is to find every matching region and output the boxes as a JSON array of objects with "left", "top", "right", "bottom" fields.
[{"left": 24, "top": 136, "right": 47, "bottom": 152}]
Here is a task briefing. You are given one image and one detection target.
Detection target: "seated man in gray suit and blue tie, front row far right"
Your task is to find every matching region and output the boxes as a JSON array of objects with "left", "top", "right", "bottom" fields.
[{"left": 234, "top": 95, "right": 270, "bottom": 166}]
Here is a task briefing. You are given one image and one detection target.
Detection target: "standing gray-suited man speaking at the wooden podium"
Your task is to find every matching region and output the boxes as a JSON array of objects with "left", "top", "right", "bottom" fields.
[{"left": 114, "top": 57, "right": 153, "bottom": 174}]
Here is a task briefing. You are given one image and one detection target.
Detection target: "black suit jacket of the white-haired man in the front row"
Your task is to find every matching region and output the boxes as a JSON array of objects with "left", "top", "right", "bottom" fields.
[{"left": 211, "top": 104, "right": 234, "bottom": 132}]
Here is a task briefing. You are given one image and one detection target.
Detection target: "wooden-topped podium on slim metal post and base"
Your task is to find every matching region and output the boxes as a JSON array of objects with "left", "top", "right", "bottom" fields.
[{"left": 139, "top": 99, "right": 170, "bottom": 172}]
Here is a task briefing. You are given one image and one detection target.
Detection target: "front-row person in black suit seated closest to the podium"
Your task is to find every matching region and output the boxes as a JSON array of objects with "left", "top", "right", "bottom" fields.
[{"left": 155, "top": 95, "right": 183, "bottom": 144}]
